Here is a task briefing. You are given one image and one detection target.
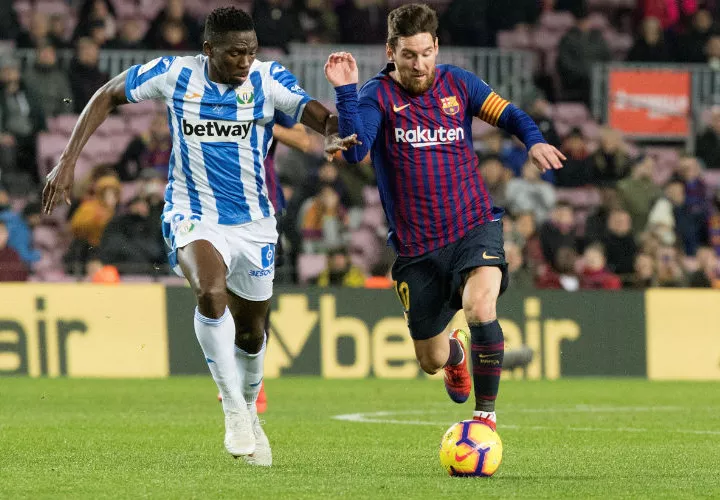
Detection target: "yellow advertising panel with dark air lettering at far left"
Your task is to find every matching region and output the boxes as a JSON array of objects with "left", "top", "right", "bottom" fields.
[{"left": 0, "top": 284, "right": 169, "bottom": 377}]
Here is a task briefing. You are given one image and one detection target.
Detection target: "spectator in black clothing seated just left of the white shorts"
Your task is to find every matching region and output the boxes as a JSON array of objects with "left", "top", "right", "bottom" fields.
[{"left": 99, "top": 196, "right": 166, "bottom": 274}]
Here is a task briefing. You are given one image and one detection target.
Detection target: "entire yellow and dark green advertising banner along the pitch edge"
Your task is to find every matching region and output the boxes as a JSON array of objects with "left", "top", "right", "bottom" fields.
[{"left": 0, "top": 284, "right": 720, "bottom": 380}]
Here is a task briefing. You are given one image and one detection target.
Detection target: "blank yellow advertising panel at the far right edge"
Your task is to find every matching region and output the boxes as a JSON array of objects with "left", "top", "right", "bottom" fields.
[{"left": 645, "top": 290, "right": 720, "bottom": 380}]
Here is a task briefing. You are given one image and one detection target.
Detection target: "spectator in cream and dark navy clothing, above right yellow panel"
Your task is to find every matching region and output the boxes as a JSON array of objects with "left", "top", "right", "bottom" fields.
[{"left": 647, "top": 179, "right": 702, "bottom": 256}]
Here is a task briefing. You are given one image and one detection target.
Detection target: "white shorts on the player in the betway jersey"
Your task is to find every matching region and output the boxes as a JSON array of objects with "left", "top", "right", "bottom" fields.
[{"left": 163, "top": 212, "right": 278, "bottom": 302}]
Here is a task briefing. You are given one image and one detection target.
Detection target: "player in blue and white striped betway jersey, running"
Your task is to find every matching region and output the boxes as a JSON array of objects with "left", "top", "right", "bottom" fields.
[{"left": 43, "top": 7, "right": 356, "bottom": 466}]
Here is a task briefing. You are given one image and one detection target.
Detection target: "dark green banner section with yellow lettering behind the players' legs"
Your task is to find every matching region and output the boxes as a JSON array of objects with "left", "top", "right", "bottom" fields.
[{"left": 167, "top": 288, "right": 647, "bottom": 378}]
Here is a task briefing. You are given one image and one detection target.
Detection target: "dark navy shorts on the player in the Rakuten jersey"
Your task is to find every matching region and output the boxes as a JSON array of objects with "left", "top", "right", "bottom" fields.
[{"left": 392, "top": 220, "right": 509, "bottom": 340}]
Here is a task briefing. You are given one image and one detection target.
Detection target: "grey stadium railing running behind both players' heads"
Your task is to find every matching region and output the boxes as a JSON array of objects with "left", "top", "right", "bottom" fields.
[{"left": 16, "top": 44, "right": 536, "bottom": 102}]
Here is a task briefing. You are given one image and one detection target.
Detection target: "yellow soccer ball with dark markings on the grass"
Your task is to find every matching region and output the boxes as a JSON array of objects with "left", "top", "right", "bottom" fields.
[{"left": 440, "top": 420, "right": 502, "bottom": 477}]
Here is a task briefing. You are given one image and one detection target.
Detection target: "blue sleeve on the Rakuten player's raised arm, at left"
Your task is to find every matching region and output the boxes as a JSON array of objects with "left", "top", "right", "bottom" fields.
[{"left": 335, "top": 84, "right": 383, "bottom": 163}]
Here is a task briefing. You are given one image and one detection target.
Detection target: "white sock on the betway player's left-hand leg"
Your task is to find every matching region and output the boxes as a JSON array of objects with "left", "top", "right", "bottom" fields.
[{"left": 195, "top": 308, "right": 245, "bottom": 412}]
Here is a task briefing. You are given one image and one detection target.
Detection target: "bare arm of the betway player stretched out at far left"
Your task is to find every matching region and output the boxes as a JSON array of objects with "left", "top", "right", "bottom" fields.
[{"left": 43, "top": 71, "right": 128, "bottom": 214}]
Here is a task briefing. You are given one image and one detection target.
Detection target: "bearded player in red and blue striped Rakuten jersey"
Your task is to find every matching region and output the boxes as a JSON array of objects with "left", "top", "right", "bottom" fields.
[{"left": 325, "top": 4, "right": 565, "bottom": 429}]
